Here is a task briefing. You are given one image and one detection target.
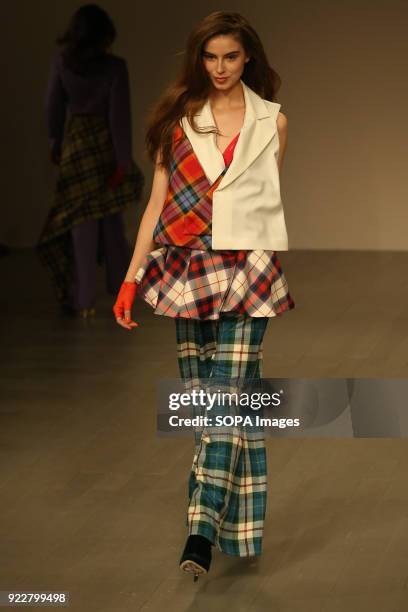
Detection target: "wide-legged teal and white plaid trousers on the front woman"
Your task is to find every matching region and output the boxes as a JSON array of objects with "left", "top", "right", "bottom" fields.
[{"left": 175, "top": 312, "right": 269, "bottom": 557}]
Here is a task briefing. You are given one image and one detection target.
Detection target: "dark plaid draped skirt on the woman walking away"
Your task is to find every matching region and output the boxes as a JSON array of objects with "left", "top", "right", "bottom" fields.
[{"left": 37, "top": 115, "right": 144, "bottom": 302}]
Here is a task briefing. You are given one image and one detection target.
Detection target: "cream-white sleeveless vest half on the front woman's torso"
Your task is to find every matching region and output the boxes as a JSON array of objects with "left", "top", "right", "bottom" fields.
[{"left": 180, "top": 79, "right": 288, "bottom": 251}]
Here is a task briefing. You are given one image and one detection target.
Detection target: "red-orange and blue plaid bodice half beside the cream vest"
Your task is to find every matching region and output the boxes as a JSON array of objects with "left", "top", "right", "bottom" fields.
[{"left": 153, "top": 126, "right": 229, "bottom": 249}]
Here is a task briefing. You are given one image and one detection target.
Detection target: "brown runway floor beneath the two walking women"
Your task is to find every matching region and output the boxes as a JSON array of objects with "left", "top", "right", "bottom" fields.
[{"left": 0, "top": 249, "right": 408, "bottom": 612}]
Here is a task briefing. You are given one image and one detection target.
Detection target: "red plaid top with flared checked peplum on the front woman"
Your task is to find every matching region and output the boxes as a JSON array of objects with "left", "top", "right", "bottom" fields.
[{"left": 135, "top": 121, "right": 295, "bottom": 319}]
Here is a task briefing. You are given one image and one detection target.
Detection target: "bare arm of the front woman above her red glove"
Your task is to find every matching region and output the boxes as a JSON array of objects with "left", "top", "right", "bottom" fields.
[{"left": 124, "top": 148, "right": 169, "bottom": 282}]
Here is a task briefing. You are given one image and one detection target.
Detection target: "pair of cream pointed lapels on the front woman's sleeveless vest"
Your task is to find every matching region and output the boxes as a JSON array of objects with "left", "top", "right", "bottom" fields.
[{"left": 180, "top": 79, "right": 280, "bottom": 191}]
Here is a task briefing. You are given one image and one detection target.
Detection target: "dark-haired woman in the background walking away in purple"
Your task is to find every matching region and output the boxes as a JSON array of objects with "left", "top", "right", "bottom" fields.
[{"left": 37, "top": 4, "right": 144, "bottom": 317}]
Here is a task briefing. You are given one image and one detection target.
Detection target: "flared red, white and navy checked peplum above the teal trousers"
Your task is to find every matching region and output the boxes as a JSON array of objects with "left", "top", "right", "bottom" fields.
[{"left": 135, "top": 246, "right": 295, "bottom": 320}]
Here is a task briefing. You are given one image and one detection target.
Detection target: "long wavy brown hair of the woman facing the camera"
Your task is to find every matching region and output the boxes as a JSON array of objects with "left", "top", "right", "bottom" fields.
[{"left": 145, "top": 11, "right": 281, "bottom": 169}]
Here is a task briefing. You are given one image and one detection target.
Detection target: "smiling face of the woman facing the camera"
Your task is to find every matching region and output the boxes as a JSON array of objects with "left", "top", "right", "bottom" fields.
[{"left": 203, "top": 34, "right": 249, "bottom": 90}]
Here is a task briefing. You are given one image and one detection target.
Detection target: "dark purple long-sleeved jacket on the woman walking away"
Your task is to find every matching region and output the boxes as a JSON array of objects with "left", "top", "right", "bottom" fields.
[{"left": 46, "top": 52, "right": 132, "bottom": 168}]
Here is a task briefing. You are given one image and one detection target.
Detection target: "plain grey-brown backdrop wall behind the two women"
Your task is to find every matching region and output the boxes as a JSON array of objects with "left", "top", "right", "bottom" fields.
[{"left": 0, "top": 0, "right": 408, "bottom": 250}]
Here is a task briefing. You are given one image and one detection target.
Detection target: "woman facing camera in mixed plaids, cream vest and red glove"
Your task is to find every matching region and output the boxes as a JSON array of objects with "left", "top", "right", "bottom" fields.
[{"left": 114, "top": 11, "right": 295, "bottom": 579}]
